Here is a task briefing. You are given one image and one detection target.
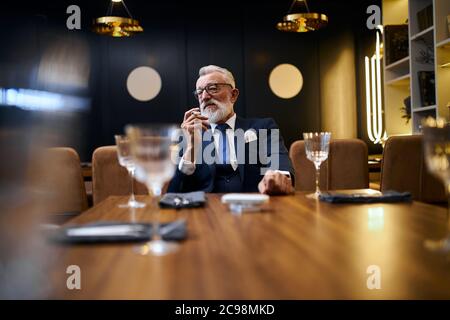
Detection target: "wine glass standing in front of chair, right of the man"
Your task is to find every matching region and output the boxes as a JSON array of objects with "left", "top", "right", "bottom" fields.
[{"left": 303, "top": 132, "right": 331, "bottom": 199}]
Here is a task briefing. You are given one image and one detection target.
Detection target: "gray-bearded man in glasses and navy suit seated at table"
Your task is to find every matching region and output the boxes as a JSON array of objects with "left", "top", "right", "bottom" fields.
[{"left": 168, "top": 65, "right": 294, "bottom": 194}]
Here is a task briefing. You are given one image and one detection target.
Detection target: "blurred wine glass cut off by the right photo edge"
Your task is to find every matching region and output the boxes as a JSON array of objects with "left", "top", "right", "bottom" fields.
[{"left": 422, "top": 118, "right": 450, "bottom": 252}]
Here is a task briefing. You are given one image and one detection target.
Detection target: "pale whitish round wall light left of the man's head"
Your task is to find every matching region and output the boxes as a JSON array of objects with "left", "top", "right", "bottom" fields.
[{"left": 127, "top": 66, "right": 162, "bottom": 101}]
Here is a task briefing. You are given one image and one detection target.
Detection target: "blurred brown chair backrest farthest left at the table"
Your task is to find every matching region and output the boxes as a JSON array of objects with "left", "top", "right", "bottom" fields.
[{"left": 30, "top": 148, "right": 88, "bottom": 215}]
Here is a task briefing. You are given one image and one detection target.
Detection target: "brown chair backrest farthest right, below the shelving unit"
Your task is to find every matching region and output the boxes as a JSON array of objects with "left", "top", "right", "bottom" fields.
[{"left": 381, "top": 135, "right": 447, "bottom": 202}]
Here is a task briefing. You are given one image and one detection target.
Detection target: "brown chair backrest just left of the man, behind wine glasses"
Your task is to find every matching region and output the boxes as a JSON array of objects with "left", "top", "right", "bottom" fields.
[{"left": 92, "top": 146, "right": 148, "bottom": 205}]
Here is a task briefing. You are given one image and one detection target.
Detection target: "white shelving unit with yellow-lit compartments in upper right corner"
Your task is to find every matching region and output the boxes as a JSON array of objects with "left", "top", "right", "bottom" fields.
[{"left": 382, "top": 0, "right": 450, "bottom": 135}]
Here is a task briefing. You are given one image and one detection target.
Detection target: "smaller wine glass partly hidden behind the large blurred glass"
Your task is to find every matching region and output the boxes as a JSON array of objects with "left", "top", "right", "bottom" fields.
[{"left": 114, "top": 135, "right": 145, "bottom": 208}]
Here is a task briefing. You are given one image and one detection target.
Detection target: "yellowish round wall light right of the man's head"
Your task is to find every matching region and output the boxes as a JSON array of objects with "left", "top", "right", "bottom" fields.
[{"left": 269, "top": 63, "right": 303, "bottom": 99}]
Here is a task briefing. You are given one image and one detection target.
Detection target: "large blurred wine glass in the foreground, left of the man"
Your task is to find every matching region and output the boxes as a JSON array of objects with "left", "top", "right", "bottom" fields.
[{"left": 125, "top": 125, "right": 179, "bottom": 256}]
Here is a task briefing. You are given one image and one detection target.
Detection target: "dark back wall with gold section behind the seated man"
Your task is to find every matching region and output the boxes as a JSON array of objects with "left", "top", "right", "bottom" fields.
[{"left": 0, "top": 0, "right": 384, "bottom": 162}]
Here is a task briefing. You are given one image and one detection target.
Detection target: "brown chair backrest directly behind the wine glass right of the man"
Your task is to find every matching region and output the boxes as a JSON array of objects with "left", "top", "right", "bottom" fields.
[{"left": 289, "top": 139, "right": 369, "bottom": 191}]
